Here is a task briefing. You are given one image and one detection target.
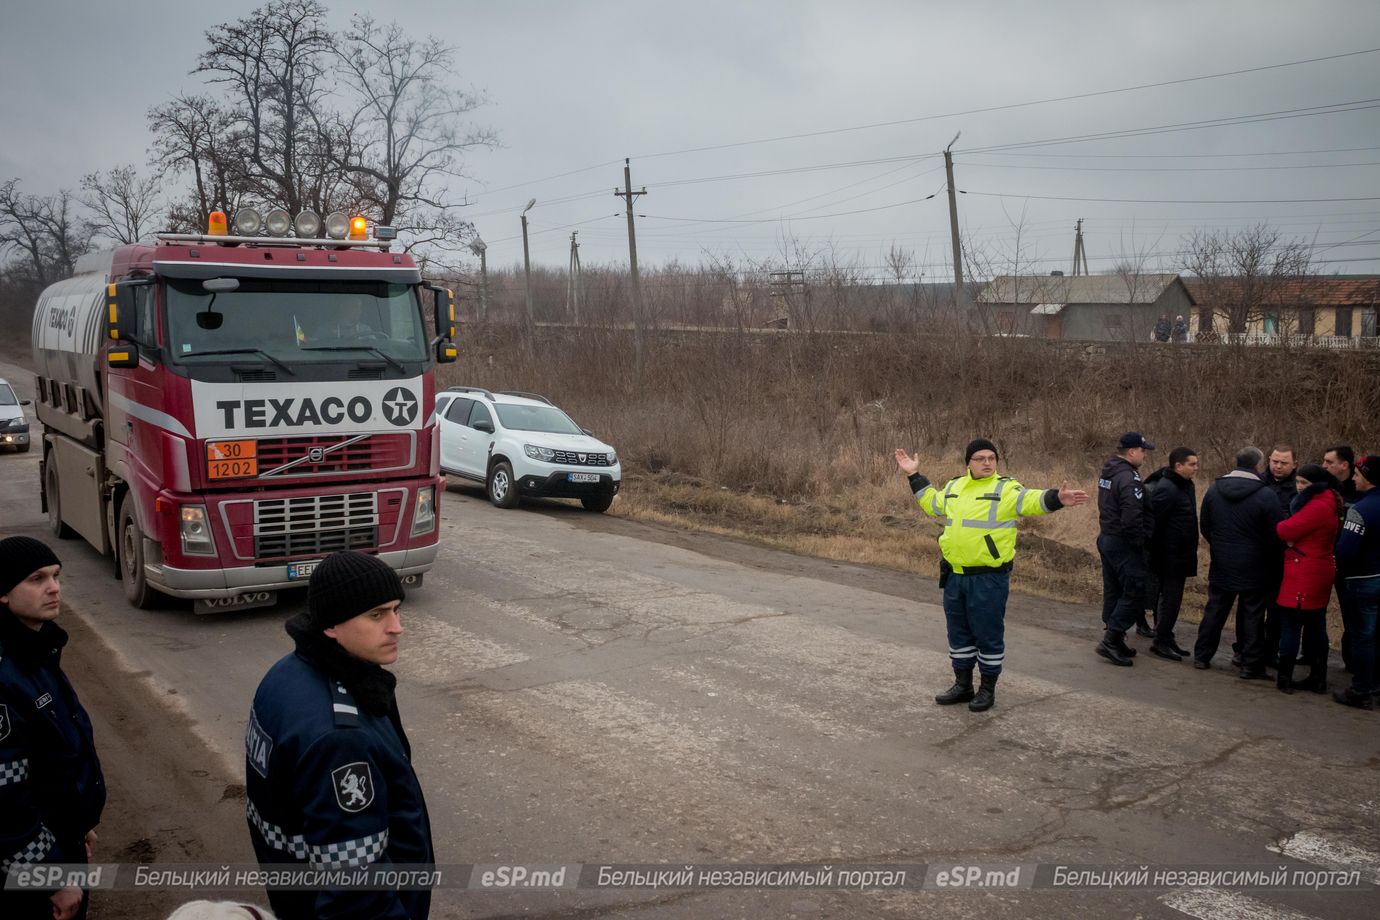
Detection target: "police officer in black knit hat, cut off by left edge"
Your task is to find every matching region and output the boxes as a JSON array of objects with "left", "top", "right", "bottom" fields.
[{"left": 0, "top": 537, "right": 105, "bottom": 920}]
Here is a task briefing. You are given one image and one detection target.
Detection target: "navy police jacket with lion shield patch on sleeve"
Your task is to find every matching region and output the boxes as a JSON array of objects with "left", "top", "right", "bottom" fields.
[{"left": 244, "top": 639, "right": 435, "bottom": 919}]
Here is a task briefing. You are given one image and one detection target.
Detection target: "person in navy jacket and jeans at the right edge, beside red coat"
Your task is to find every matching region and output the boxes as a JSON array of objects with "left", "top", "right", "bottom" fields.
[{"left": 1333, "top": 457, "right": 1380, "bottom": 709}]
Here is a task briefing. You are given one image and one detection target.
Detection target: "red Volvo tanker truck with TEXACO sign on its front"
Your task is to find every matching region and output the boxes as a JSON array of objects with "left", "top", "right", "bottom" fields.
[{"left": 33, "top": 208, "right": 457, "bottom": 612}]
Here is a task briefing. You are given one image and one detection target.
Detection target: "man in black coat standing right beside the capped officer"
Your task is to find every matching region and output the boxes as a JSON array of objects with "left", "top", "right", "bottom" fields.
[{"left": 1145, "top": 447, "right": 1198, "bottom": 661}]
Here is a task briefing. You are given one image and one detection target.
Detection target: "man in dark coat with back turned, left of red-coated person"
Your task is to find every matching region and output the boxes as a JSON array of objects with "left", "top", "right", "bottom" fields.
[{"left": 1194, "top": 447, "right": 1283, "bottom": 680}]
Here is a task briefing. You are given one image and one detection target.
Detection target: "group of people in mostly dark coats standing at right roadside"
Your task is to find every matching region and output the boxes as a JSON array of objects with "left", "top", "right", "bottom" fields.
[{"left": 1097, "top": 441, "right": 1380, "bottom": 709}]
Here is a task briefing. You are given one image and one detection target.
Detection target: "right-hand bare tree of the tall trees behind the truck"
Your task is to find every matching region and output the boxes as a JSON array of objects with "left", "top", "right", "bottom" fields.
[{"left": 334, "top": 14, "right": 497, "bottom": 241}]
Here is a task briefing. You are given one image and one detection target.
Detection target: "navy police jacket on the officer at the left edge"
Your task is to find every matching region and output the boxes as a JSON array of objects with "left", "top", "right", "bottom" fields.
[{"left": 0, "top": 604, "right": 105, "bottom": 917}]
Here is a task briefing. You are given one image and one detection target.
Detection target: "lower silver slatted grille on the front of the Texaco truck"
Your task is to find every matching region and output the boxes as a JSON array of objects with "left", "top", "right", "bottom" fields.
[{"left": 254, "top": 492, "right": 378, "bottom": 559}]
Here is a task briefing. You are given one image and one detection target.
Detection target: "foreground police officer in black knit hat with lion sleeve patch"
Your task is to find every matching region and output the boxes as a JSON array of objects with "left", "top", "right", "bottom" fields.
[{"left": 244, "top": 552, "right": 435, "bottom": 920}]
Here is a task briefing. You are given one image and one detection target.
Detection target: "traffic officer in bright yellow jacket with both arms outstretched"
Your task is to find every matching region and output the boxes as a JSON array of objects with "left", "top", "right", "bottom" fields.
[{"left": 896, "top": 437, "right": 1087, "bottom": 712}]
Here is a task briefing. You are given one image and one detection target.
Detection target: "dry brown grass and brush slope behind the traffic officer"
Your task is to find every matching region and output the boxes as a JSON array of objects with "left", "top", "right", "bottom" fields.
[{"left": 460, "top": 327, "right": 1380, "bottom": 637}]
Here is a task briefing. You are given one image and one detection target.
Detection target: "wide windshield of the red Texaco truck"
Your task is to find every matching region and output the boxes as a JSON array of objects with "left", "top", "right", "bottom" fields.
[{"left": 167, "top": 279, "right": 426, "bottom": 364}]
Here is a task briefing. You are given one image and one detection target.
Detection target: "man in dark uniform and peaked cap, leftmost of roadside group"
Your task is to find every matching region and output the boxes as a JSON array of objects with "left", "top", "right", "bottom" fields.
[{"left": 1097, "top": 432, "right": 1155, "bottom": 668}]
